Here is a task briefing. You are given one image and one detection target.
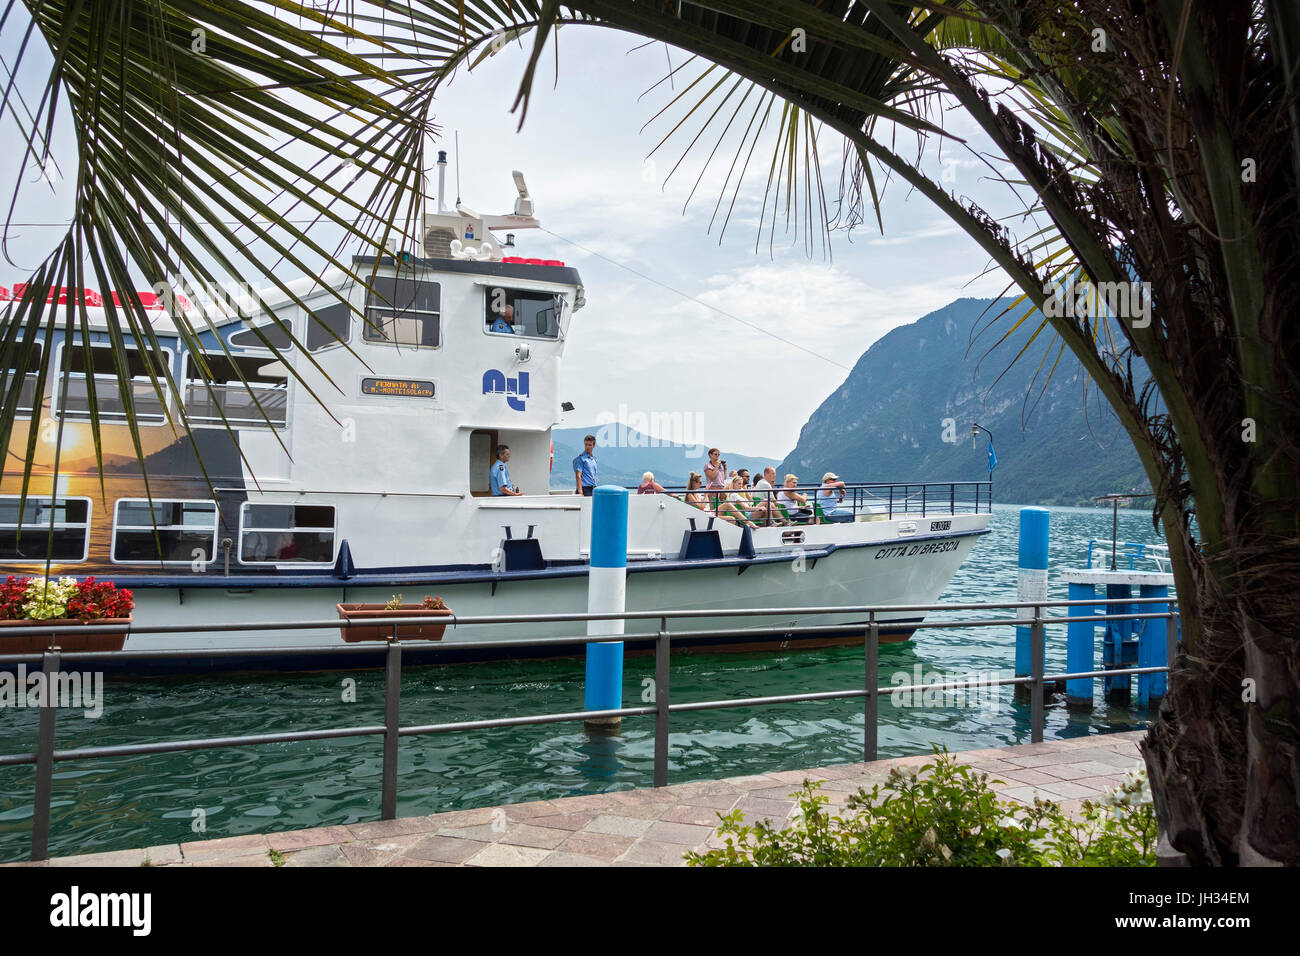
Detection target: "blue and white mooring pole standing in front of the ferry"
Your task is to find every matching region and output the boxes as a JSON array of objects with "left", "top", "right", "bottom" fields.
[{"left": 582, "top": 485, "right": 628, "bottom": 731}]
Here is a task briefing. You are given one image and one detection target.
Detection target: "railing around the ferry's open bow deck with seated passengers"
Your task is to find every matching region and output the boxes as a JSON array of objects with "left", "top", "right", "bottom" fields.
[{"left": 628, "top": 481, "right": 993, "bottom": 528}]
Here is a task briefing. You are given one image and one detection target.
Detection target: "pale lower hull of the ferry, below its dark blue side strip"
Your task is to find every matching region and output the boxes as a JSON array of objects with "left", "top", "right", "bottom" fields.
[{"left": 124, "top": 531, "right": 980, "bottom": 672}]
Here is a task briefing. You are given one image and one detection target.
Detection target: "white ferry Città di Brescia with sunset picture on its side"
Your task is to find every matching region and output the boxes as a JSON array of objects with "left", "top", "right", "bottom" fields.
[{"left": 0, "top": 159, "right": 992, "bottom": 672}]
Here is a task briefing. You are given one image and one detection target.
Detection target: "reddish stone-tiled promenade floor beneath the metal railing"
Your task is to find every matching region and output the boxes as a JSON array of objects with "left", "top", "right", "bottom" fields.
[{"left": 9, "top": 731, "right": 1144, "bottom": 866}]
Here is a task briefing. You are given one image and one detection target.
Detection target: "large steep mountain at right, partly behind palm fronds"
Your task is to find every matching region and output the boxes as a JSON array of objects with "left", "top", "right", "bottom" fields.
[{"left": 777, "top": 299, "right": 1149, "bottom": 505}]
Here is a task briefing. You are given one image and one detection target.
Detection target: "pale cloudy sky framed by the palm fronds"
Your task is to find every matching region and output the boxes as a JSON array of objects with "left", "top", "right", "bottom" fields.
[{"left": 0, "top": 17, "right": 1028, "bottom": 458}]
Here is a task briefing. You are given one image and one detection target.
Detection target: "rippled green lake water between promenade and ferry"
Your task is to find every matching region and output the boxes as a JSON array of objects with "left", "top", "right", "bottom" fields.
[{"left": 0, "top": 505, "right": 1161, "bottom": 861}]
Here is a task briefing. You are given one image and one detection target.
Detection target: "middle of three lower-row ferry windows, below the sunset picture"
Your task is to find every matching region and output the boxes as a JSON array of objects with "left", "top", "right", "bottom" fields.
[{"left": 112, "top": 498, "right": 217, "bottom": 564}]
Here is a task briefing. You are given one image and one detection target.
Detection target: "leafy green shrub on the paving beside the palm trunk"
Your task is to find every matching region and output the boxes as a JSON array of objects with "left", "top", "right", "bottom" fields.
[{"left": 686, "top": 749, "right": 1157, "bottom": 866}]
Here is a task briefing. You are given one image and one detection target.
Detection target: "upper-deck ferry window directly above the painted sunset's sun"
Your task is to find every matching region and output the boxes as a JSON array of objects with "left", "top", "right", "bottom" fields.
[{"left": 55, "top": 342, "right": 172, "bottom": 425}]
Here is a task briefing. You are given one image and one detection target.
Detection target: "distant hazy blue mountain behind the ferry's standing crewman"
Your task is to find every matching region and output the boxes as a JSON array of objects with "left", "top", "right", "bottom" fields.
[{"left": 551, "top": 423, "right": 776, "bottom": 488}]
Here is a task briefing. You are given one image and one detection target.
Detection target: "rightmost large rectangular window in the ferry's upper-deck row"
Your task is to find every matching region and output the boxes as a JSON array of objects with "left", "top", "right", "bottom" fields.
[{"left": 185, "top": 352, "right": 289, "bottom": 427}]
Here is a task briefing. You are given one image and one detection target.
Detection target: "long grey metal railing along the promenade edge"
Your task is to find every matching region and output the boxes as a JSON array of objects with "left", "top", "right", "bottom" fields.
[{"left": 0, "top": 597, "right": 1178, "bottom": 860}]
